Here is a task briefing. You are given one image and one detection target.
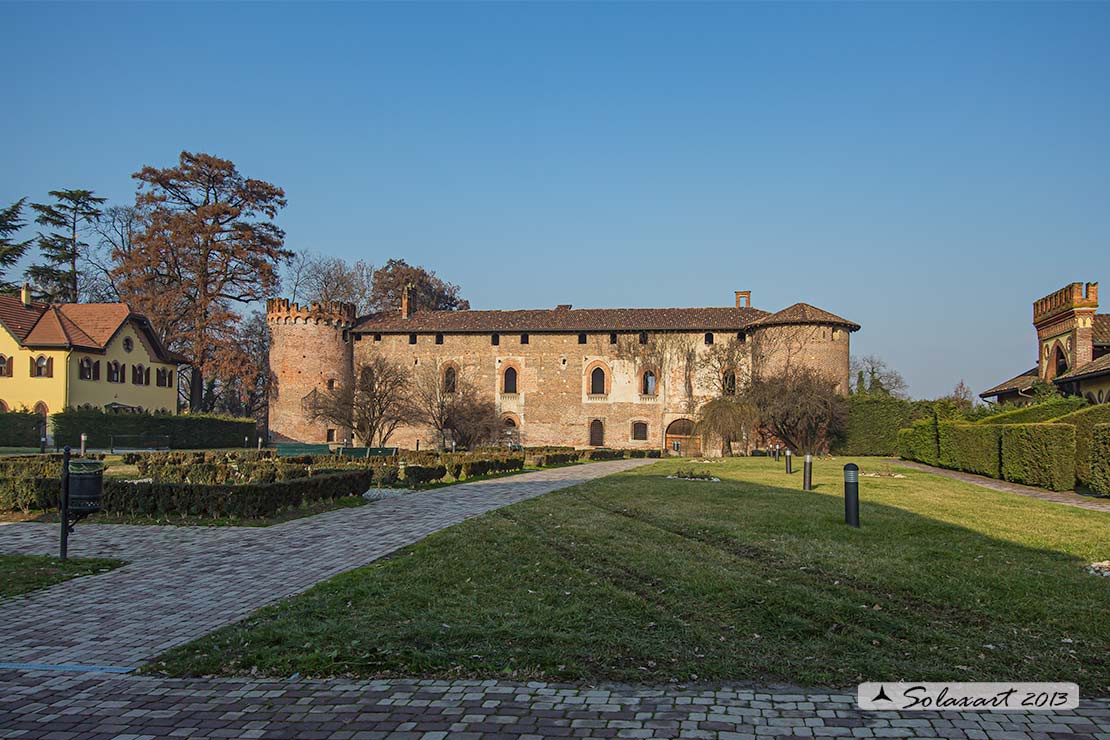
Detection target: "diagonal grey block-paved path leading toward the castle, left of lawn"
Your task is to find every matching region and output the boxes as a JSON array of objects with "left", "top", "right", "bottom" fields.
[{"left": 0, "top": 459, "right": 654, "bottom": 669}]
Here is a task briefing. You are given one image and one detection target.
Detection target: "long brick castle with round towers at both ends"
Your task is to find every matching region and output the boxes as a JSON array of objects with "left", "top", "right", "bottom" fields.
[{"left": 266, "top": 291, "right": 859, "bottom": 454}]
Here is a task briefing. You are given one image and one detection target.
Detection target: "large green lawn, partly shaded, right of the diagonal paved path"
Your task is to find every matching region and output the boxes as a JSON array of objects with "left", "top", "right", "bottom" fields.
[{"left": 148, "top": 458, "right": 1110, "bottom": 696}]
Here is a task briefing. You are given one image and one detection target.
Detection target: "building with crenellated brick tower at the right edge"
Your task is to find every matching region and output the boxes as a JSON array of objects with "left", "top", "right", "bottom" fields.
[{"left": 979, "top": 283, "right": 1110, "bottom": 405}]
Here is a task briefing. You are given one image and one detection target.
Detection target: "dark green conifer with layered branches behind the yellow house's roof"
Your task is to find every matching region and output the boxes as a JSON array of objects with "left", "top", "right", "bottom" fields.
[{"left": 27, "top": 190, "right": 105, "bottom": 303}]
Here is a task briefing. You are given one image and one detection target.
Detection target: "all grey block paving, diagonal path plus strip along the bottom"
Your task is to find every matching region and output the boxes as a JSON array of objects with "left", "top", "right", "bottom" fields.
[{"left": 0, "top": 460, "right": 1110, "bottom": 740}]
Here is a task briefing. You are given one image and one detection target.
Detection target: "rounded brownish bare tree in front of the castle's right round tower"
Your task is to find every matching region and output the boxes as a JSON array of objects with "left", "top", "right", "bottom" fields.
[{"left": 744, "top": 366, "right": 848, "bottom": 455}]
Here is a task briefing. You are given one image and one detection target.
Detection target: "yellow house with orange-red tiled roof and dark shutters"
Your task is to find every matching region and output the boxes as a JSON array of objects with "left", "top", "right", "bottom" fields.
[{"left": 0, "top": 286, "right": 188, "bottom": 428}]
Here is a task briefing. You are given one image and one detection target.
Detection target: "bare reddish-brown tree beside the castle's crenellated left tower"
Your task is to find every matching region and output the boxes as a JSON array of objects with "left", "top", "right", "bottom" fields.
[{"left": 304, "top": 355, "right": 412, "bottom": 446}]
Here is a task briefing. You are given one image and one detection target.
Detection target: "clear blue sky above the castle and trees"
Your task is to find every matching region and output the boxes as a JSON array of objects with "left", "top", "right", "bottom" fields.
[{"left": 0, "top": 2, "right": 1110, "bottom": 397}]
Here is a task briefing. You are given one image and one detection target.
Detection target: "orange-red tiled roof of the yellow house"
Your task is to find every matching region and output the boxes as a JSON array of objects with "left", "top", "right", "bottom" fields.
[{"left": 0, "top": 294, "right": 189, "bottom": 363}]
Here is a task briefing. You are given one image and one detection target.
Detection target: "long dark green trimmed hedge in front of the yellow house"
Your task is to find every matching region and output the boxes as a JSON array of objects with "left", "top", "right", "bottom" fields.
[{"left": 50, "top": 408, "right": 258, "bottom": 449}]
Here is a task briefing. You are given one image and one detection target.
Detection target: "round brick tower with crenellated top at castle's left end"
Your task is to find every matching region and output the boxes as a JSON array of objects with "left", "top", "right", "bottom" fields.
[{"left": 266, "top": 298, "right": 355, "bottom": 444}]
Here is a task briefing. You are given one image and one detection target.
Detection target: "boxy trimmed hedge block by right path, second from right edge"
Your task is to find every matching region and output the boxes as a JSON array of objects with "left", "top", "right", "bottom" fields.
[{"left": 1002, "top": 424, "right": 1076, "bottom": 490}]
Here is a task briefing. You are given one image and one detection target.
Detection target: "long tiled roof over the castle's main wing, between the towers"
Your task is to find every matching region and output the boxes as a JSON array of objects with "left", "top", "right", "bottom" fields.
[{"left": 354, "top": 306, "right": 772, "bottom": 333}]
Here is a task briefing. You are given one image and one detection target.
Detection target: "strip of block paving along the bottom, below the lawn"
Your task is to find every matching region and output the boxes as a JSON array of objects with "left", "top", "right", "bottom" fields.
[{"left": 0, "top": 671, "right": 1110, "bottom": 740}]
